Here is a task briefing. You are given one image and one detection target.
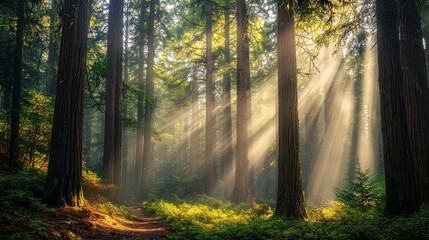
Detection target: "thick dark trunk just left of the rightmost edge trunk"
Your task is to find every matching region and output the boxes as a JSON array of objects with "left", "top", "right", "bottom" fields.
[{"left": 376, "top": 0, "right": 420, "bottom": 214}]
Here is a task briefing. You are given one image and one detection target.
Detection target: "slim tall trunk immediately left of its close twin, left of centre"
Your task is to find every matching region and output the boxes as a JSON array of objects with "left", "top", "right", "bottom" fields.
[{"left": 135, "top": 0, "right": 146, "bottom": 200}]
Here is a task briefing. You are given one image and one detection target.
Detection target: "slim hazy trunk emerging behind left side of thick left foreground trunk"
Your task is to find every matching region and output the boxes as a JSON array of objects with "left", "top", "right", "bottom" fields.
[{"left": 46, "top": 0, "right": 58, "bottom": 96}]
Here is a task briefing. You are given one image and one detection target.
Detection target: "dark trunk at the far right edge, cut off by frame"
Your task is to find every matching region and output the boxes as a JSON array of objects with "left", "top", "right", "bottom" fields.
[{"left": 399, "top": 0, "right": 429, "bottom": 202}]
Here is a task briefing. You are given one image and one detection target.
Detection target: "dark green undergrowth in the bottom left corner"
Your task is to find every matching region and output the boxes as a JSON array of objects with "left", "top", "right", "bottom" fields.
[{"left": 0, "top": 169, "right": 49, "bottom": 239}]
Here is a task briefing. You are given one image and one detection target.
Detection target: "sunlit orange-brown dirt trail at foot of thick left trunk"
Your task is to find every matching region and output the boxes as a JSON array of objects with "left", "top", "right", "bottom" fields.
[{"left": 49, "top": 206, "right": 169, "bottom": 240}]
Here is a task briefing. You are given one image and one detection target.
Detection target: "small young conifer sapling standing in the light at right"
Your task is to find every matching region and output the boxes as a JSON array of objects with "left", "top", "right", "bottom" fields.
[{"left": 336, "top": 166, "right": 384, "bottom": 211}]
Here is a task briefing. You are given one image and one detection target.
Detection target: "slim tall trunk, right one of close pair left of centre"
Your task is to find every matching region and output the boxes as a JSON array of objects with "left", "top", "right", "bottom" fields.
[{"left": 142, "top": 0, "right": 158, "bottom": 200}]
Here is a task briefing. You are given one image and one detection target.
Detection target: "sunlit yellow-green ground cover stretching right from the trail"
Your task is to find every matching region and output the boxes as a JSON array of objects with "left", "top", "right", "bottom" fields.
[{"left": 143, "top": 196, "right": 429, "bottom": 240}]
